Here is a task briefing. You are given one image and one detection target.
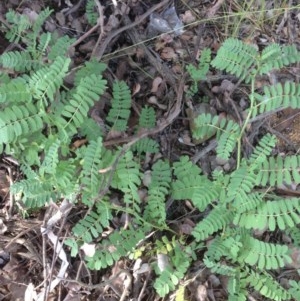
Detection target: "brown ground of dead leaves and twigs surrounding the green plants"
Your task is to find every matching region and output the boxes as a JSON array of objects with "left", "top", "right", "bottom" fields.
[{"left": 0, "top": 0, "right": 300, "bottom": 301}]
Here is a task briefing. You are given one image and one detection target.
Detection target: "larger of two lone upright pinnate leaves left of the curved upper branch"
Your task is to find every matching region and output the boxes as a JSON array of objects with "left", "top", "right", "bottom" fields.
[{"left": 107, "top": 81, "right": 131, "bottom": 131}]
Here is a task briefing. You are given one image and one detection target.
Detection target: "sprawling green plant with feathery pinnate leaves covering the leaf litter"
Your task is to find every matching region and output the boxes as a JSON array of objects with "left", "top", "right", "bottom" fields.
[{"left": 0, "top": 10, "right": 300, "bottom": 301}]
